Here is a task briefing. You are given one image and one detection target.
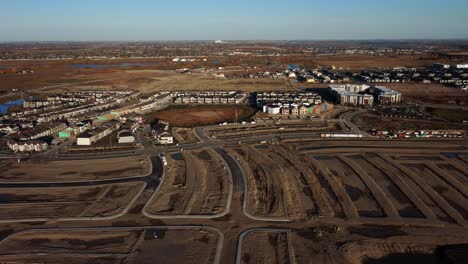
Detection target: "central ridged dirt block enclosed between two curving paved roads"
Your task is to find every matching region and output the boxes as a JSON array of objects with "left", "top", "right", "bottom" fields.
[{"left": 145, "top": 149, "right": 229, "bottom": 215}]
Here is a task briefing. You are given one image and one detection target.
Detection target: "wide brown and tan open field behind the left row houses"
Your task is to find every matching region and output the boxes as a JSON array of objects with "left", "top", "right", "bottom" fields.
[{"left": 0, "top": 62, "right": 291, "bottom": 93}]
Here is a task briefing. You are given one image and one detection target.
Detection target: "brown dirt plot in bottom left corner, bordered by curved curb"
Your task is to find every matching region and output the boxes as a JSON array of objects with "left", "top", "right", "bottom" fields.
[{"left": 0, "top": 228, "right": 218, "bottom": 264}]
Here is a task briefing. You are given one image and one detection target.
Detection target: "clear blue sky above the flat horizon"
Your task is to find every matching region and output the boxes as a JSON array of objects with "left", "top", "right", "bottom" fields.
[{"left": 0, "top": 0, "right": 468, "bottom": 41}]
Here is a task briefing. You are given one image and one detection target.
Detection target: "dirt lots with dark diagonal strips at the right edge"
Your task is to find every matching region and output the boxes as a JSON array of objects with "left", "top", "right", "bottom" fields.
[{"left": 298, "top": 142, "right": 468, "bottom": 224}]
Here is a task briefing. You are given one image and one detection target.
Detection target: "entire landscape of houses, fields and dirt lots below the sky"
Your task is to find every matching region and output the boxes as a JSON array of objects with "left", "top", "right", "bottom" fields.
[{"left": 0, "top": 40, "right": 468, "bottom": 264}]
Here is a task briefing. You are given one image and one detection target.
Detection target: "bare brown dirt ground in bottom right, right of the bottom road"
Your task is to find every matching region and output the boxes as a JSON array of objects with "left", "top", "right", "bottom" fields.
[{"left": 241, "top": 224, "right": 466, "bottom": 264}]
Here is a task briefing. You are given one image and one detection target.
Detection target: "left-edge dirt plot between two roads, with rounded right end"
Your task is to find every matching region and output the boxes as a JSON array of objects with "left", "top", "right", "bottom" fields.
[{"left": 0, "top": 182, "right": 145, "bottom": 222}]
